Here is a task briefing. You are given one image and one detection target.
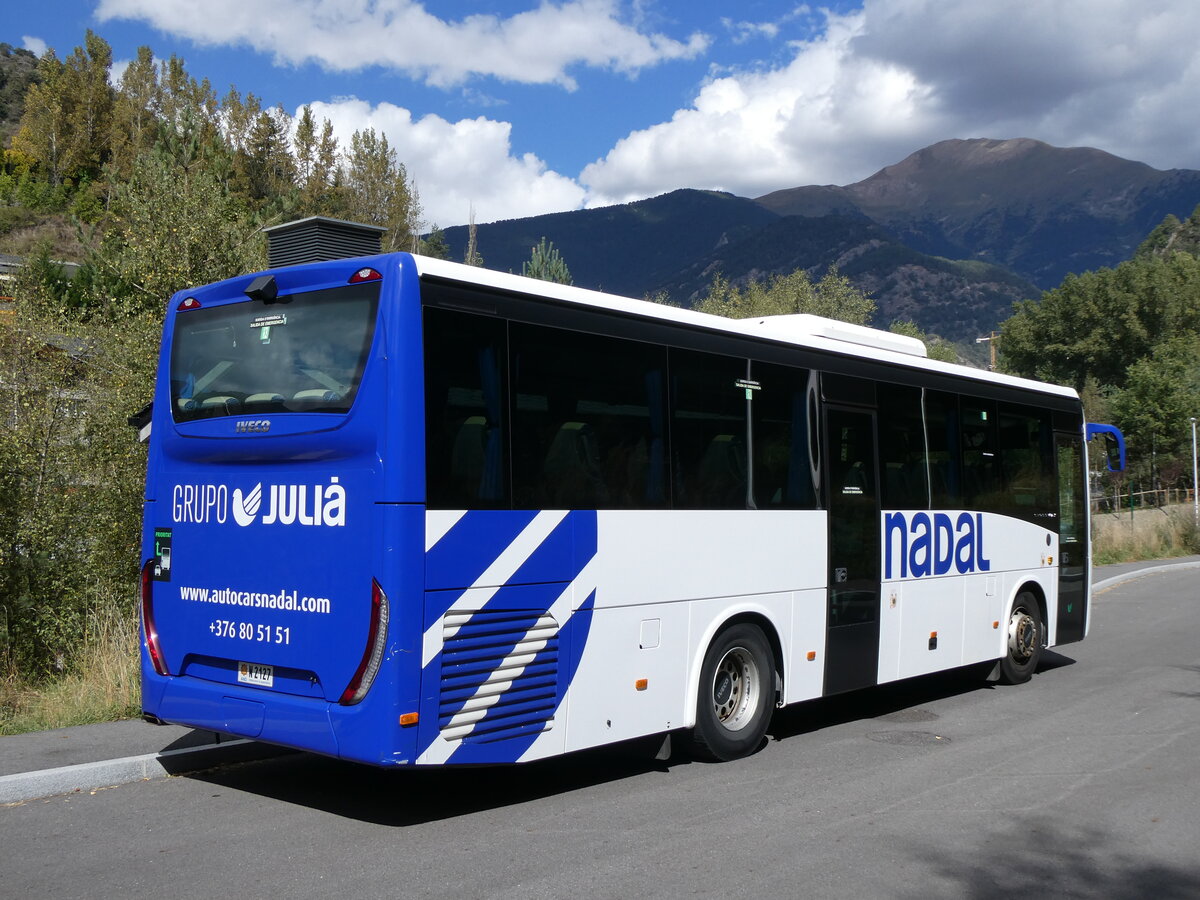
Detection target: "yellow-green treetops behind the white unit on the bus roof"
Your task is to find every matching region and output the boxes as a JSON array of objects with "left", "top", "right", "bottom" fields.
[{"left": 695, "top": 268, "right": 875, "bottom": 325}]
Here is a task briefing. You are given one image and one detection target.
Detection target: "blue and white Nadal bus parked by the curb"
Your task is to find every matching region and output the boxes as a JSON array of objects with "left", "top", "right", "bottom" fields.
[{"left": 142, "top": 247, "right": 1123, "bottom": 766}]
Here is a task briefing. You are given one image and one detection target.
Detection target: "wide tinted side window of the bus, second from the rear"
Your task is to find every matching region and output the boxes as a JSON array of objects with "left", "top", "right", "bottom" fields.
[{"left": 510, "top": 323, "right": 667, "bottom": 509}]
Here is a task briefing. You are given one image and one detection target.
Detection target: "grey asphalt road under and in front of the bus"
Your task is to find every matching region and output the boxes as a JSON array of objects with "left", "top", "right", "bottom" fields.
[{"left": 0, "top": 569, "right": 1200, "bottom": 900}]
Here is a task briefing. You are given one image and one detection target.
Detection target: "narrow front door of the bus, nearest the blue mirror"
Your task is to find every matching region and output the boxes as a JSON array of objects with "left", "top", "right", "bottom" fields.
[{"left": 1055, "top": 433, "right": 1087, "bottom": 643}]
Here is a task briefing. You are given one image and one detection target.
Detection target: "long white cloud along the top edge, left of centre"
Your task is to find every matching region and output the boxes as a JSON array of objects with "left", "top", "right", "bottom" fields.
[{"left": 96, "top": 0, "right": 708, "bottom": 88}]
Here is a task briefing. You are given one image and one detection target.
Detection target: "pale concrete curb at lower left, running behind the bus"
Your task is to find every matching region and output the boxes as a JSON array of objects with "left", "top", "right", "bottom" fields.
[{"left": 0, "top": 740, "right": 295, "bottom": 804}]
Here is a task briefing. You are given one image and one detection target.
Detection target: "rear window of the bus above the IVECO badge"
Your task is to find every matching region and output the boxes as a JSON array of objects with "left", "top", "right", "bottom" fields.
[{"left": 170, "top": 282, "right": 379, "bottom": 422}]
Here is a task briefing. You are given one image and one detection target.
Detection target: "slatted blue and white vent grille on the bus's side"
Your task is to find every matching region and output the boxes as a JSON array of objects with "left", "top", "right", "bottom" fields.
[{"left": 438, "top": 610, "right": 558, "bottom": 743}]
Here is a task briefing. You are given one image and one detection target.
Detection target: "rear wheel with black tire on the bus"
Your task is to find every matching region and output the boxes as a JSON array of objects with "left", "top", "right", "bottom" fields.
[{"left": 691, "top": 623, "right": 775, "bottom": 762}]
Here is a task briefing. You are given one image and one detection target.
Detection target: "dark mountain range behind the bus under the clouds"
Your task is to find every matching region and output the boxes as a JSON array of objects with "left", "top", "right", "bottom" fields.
[{"left": 445, "top": 138, "right": 1200, "bottom": 341}]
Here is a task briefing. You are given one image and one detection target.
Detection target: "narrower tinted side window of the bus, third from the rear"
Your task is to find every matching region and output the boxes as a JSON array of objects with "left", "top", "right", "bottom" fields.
[{"left": 671, "top": 350, "right": 750, "bottom": 509}]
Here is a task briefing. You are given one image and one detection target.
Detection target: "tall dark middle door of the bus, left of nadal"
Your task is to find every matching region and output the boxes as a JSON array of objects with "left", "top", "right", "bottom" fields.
[{"left": 824, "top": 407, "right": 880, "bottom": 695}]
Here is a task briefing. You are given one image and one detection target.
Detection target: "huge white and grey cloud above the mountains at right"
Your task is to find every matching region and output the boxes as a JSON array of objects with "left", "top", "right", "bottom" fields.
[{"left": 581, "top": 0, "right": 1200, "bottom": 204}]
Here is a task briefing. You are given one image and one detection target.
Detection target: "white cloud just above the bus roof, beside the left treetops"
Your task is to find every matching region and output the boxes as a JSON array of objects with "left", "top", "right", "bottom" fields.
[{"left": 304, "top": 98, "right": 584, "bottom": 227}]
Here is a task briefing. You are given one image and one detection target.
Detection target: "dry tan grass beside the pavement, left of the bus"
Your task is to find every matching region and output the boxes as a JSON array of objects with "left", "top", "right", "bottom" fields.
[{"left": 0, "top": 614, "right": 142, "bottom": 734}]
